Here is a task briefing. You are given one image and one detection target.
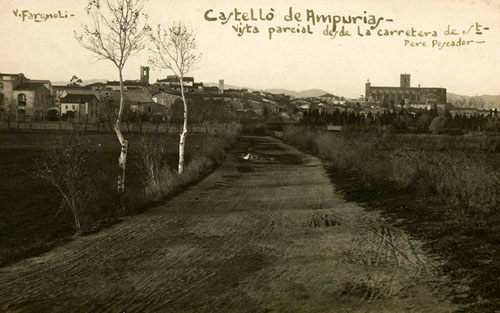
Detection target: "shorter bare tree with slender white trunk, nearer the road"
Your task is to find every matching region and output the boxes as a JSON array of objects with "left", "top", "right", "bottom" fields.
[{"left": 150, "top": 22, "right": 200, "bottom": 174}]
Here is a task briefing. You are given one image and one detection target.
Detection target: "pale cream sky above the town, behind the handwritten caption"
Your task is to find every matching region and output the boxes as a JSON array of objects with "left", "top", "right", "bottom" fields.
[{"left": 0, "top": 0, "right": 500, "bottom": 97}]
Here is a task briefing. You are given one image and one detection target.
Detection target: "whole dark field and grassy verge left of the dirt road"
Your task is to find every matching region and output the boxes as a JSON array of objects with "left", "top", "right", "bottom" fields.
[{"left": 0, "top": 129, "right": 237, "bottom": 267}]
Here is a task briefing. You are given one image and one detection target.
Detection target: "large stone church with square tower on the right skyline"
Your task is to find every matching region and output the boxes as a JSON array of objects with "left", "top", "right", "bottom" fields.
[{"left": 365, "top": 74, "right": 446, "bottom": 108}]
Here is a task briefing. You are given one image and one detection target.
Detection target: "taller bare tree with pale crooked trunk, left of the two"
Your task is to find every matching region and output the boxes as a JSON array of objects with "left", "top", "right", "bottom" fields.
[{"left": 75, "top": 0, "right": 149, "bottom": 193}]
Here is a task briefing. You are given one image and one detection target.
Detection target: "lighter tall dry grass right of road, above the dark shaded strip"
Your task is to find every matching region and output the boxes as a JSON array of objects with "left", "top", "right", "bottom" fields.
[{"left": 285, "top": 127, "right": 500, "bottom": 218}]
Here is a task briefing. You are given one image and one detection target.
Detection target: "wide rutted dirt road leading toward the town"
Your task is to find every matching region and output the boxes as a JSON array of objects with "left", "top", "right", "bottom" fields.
[{"left": 0, "top": 136, "right": 454, "bottom": 313}]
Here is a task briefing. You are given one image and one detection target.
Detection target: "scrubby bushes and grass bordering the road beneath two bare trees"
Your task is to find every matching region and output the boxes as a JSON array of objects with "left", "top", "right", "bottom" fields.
[{"left": 35, "top": 133, "right": 236, "bottom": 233}]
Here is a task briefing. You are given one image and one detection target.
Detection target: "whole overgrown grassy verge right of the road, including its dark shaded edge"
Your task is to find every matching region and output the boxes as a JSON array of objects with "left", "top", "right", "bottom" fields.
[{"left": 285, "top": 127, "right": 500, "bottom": 312}]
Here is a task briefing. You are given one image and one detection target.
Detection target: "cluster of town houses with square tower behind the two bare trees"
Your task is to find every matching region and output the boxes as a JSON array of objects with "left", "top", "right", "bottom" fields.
[{"left": 0, "top": 66, "right": 306, "bottom": 123}]
